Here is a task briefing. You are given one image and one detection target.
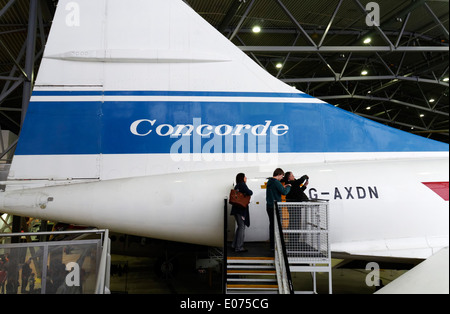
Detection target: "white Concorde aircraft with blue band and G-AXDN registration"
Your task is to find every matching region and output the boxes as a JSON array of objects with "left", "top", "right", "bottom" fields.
[{"left": 0, "top": 0, "right": 449, "bottom": 259}]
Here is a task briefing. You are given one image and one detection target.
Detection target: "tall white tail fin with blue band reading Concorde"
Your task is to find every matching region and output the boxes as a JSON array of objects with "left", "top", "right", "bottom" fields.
[{"left": 9, "top": 0, "right": 448, "bottom": 184}]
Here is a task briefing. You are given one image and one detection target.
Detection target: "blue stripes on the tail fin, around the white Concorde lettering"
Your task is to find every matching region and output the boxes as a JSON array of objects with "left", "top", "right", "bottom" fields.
[{"left": 16, "top": 91, "right": 448, "bottom": 155}]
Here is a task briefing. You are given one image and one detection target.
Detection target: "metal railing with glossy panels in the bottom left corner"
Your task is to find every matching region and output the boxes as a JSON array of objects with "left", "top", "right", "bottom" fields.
[{"left": 0, "top": 230, "right": 111, "bottom": 294}]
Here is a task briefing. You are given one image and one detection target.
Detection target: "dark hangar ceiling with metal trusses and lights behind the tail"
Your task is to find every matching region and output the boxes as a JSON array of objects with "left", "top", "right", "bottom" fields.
[{"left": 0, "top": 0, "right": 449, "bottom": 162}]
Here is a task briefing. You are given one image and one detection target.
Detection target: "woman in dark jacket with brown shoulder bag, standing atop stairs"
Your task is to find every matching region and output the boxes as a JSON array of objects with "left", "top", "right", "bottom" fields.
[{"left": 231, "top": 173, "right": 253, "bottom": 252}]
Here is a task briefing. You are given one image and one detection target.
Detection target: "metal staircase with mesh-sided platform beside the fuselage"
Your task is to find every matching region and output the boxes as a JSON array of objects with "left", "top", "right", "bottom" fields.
[{"left": 223, "top": 200, "right": 332, "bottom": 294}]
